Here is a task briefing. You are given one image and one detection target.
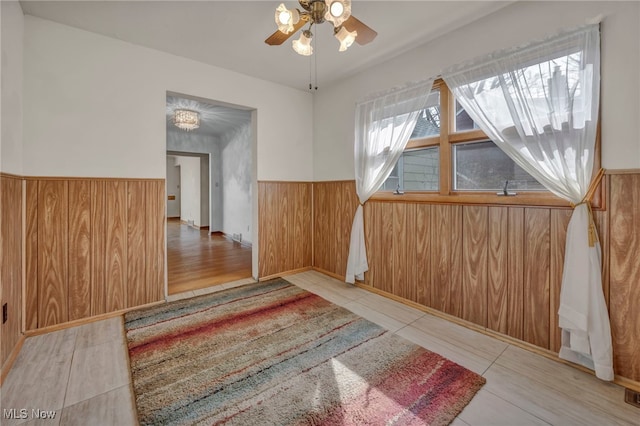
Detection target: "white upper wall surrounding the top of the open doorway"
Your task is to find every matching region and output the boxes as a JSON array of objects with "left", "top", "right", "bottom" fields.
[{"left": 24, "top": 15, "right": 313, "bottom": 181}]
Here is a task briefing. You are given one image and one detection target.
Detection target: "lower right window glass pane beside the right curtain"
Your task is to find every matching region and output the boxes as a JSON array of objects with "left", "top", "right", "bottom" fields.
[{"left": 453, "top": 141, "right": 545, "bottom": 191}]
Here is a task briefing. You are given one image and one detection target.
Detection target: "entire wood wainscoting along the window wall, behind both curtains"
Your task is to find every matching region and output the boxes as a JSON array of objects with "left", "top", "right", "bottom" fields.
[{"left": 313, "top": 172, "right": 640, "bottom": 382}]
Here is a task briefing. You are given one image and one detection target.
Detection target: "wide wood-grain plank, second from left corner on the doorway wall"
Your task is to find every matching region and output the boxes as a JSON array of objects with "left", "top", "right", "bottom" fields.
[{"left": 38, "top": 180, "right": 69, "bottom": 327}]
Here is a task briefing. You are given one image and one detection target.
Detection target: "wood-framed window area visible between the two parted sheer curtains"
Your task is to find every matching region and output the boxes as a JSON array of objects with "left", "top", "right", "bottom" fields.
[{"left": 374, "top": 80, "right": 599, "bottom": 205}]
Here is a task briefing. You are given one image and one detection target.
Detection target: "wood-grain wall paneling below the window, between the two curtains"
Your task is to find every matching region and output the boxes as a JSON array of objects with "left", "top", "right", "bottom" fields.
[{"left": 365, "top": 201, "right": 570, "bottom": 351}]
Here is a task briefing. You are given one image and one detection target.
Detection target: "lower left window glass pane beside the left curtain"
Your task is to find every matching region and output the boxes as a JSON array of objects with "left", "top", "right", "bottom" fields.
[{"left": 381, "top": 146, "right": 440, "bottom": 191}]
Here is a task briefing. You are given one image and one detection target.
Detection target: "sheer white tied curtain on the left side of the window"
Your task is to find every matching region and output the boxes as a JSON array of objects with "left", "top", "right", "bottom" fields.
[{"left": 345, "top": 78, "right": 433, "bottom": 283}]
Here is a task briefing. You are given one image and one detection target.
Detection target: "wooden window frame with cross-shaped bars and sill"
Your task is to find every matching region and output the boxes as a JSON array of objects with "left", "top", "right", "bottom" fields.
[{"left": 371, "top": 79, "right": 605, "bottom": 209}]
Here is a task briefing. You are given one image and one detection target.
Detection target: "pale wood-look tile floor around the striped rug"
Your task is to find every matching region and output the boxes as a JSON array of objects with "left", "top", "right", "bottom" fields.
[{"left": 0, "top": 271, "right": 640, "bottom": 426}]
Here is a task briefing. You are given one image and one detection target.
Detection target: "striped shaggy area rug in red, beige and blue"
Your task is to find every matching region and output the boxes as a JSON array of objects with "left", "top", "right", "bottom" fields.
[{"left": 125, "top": 279, "right": 485, "bottom": 426}]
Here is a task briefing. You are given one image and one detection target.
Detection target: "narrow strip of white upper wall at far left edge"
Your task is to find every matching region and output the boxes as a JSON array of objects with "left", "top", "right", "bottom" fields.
[{"left": 0, "top": 0, "right": 24, "bottom": 175}]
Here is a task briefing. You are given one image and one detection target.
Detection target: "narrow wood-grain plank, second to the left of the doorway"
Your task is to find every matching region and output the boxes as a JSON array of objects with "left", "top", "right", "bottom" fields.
[{"left": 126, "top": 181, "right": 148, "bottom": 308}]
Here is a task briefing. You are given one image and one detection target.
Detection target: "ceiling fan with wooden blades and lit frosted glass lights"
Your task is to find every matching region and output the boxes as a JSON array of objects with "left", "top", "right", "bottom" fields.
[{"left": 265, "top": 0, "right": 378, "bottom": 56}]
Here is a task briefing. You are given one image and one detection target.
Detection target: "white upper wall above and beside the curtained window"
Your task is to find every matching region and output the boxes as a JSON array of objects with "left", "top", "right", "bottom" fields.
[{"left": 313, "top": 2, "right": 640, "bottom": 181}]
